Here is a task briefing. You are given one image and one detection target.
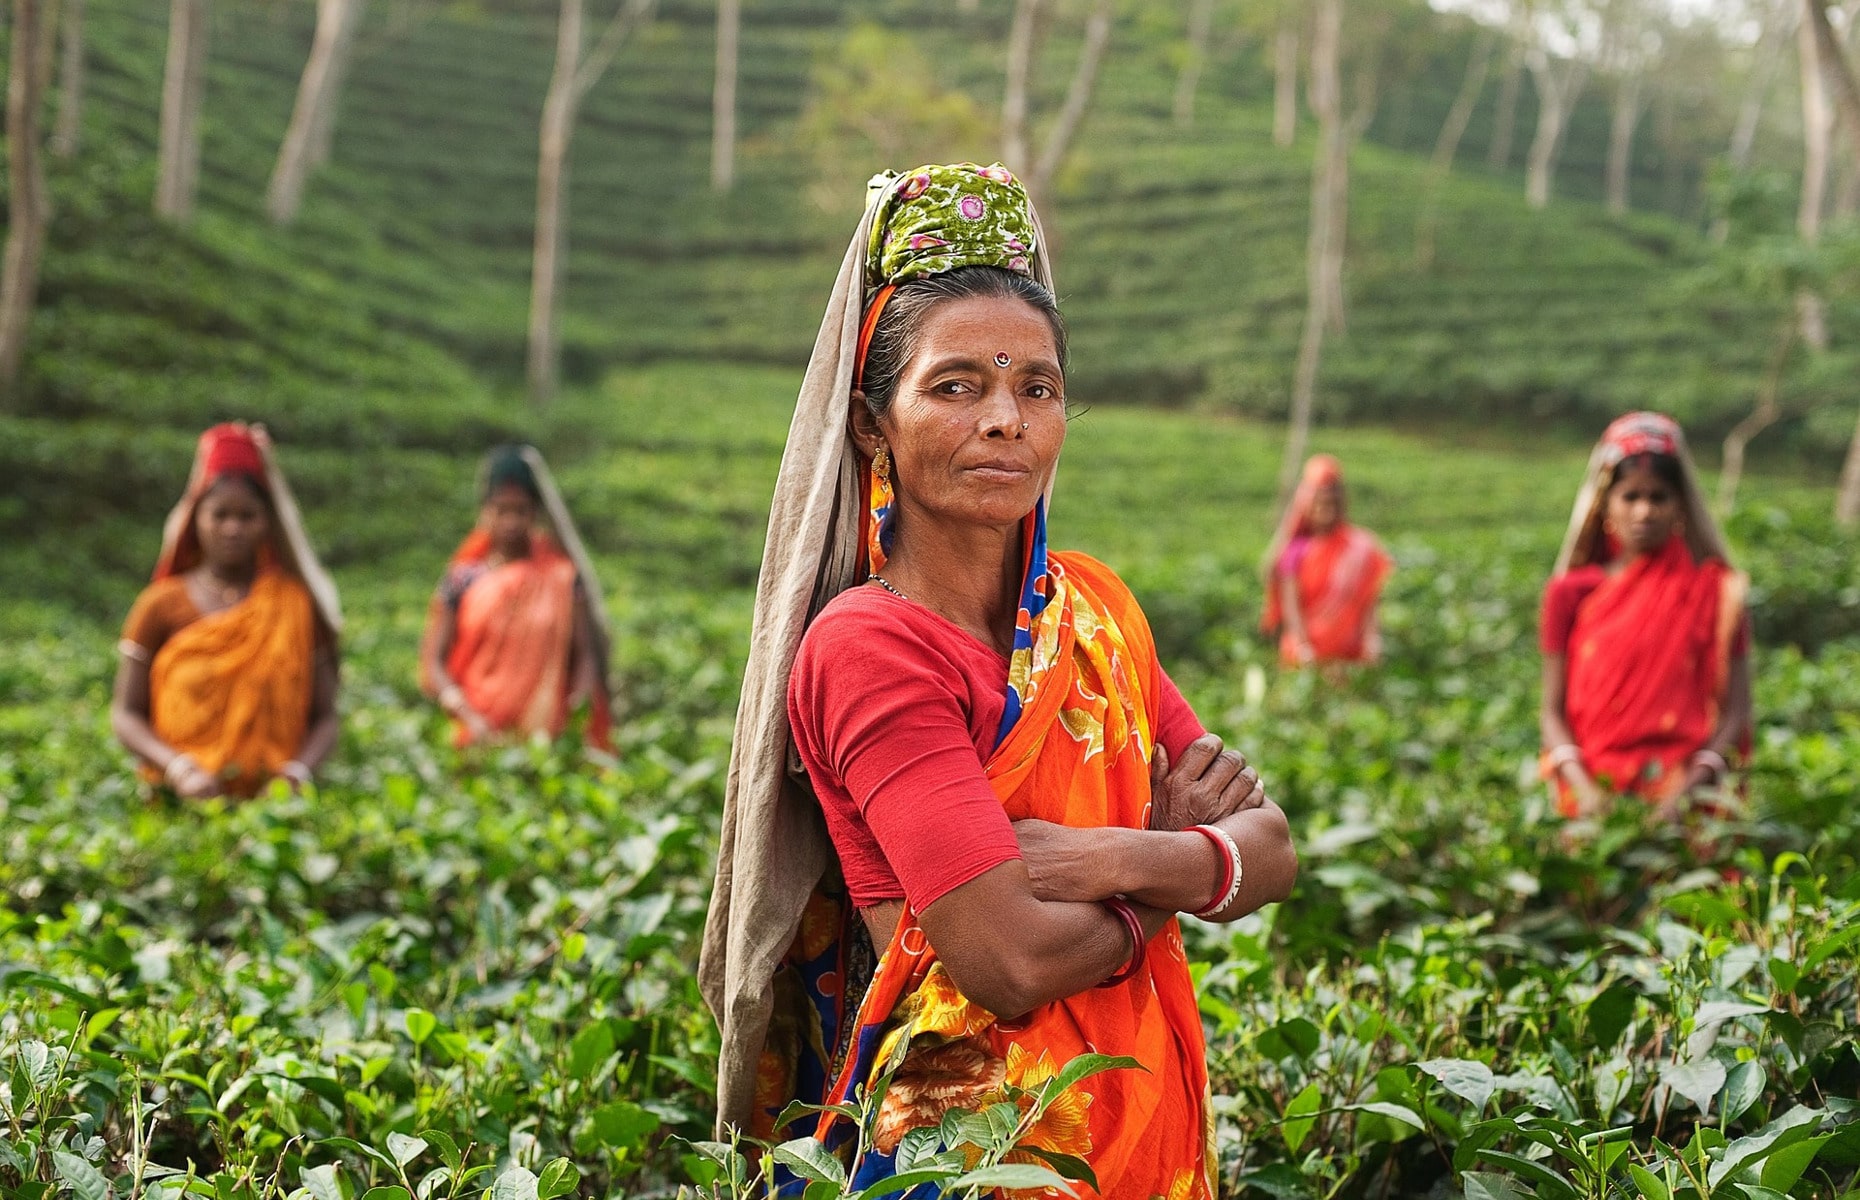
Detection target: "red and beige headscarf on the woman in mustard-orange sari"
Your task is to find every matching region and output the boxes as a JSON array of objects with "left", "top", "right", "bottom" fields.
[{"left": 153, "top": 420, "right": 342, "bottom": 634}]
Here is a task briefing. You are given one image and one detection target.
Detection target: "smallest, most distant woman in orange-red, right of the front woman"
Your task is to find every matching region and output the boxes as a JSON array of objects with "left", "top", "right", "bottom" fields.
[{"left": 1261, "top": 454, "right": 1393, "bottom": 666}]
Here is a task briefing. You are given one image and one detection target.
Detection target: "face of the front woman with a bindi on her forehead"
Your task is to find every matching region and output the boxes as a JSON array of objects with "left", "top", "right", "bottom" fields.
[{"left": 861, "top": 296, "right": 1066, "bottom": 536}]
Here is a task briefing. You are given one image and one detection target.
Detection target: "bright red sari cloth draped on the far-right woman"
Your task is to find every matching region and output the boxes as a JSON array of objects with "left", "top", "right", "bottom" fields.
[{"left": 1559, "top": 538, "right": 1745, "bottom": 815}]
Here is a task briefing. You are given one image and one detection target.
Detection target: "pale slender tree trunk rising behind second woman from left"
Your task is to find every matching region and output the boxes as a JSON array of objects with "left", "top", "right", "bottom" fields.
[{"left": 528, "top": 0, "right": 582, "bottom": 404}]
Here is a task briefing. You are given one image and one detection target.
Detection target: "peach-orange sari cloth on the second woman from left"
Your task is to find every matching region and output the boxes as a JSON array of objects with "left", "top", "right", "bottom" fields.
[{"left": 422, "top": 530, "right": 608, "bottom": 748}]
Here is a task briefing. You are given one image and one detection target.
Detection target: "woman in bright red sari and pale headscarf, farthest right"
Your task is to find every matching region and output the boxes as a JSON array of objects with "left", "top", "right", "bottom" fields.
[{"left": 1542, "top": 413, "right": 1750, "bottom": 817}]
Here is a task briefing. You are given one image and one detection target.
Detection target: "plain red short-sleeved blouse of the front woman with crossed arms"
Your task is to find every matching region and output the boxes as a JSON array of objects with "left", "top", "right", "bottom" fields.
[{"left": 789, "top": 588, "right": 1203, "bottom": 912}]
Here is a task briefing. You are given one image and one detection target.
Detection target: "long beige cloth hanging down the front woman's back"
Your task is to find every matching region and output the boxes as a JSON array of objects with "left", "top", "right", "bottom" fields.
[{"left": 698, "top": 175, "right": 1053, "bottom": 1133}]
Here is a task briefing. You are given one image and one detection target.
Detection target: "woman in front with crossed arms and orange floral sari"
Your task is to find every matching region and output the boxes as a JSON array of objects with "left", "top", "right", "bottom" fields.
[{"left": 699, "top": 164, "right": 1296, "bottom": 1198}]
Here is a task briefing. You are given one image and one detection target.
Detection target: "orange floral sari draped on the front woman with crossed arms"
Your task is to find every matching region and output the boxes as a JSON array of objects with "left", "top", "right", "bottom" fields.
[{"left": 818, "top": 554, "right": 1215, "bottom": 1200}]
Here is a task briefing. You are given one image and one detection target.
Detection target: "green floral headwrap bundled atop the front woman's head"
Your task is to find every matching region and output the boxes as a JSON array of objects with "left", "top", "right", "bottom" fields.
[{"left": 865, "top": 162, "right": 1038, "bottom": 287}]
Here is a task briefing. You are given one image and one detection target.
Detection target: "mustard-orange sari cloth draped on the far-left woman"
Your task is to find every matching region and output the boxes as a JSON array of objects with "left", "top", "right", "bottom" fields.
[{"left": 149, "top": 566, "right": 316, "bottom": 796}]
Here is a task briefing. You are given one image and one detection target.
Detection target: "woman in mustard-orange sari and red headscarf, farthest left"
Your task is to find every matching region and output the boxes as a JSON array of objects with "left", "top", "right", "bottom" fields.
[{"left": 110, "top": 424, "right": 342, "bottom": 800}]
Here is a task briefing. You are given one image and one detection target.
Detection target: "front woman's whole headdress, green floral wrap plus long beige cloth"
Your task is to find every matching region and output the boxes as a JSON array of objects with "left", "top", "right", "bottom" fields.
[{"left": 698, "top": 164, "right": 1053, "bottom": 1129}]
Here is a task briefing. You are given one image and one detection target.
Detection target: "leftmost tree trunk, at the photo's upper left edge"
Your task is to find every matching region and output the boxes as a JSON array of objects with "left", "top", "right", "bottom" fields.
[{"left": 0, "top": 0, "right": 50, "bottom": 398}]
